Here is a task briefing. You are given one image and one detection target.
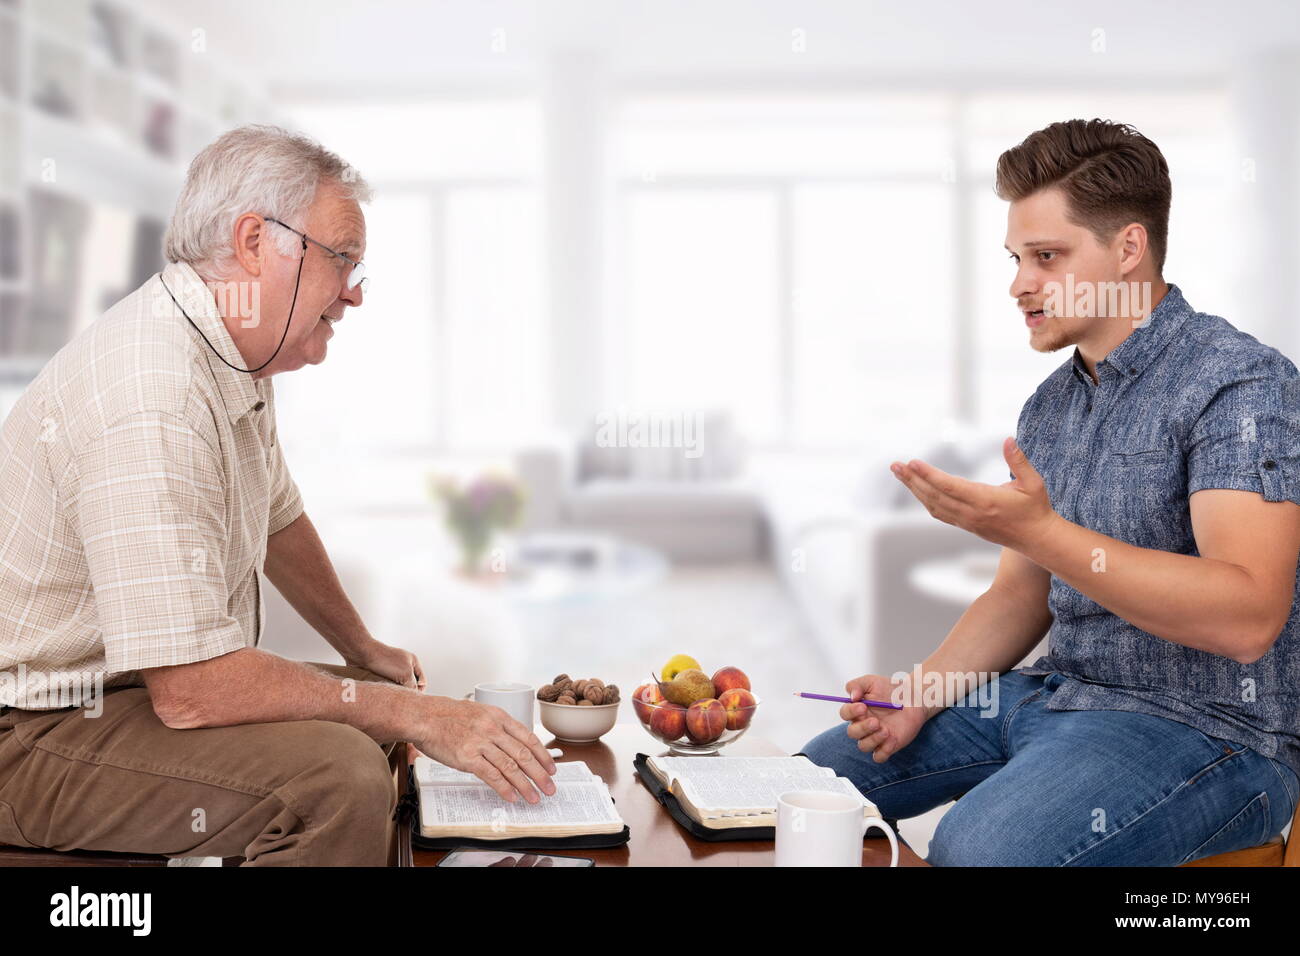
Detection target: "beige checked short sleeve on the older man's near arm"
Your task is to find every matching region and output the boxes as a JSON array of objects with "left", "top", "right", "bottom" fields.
[{"left": 64, "top": 412, "right": 247, "bottom": 674}]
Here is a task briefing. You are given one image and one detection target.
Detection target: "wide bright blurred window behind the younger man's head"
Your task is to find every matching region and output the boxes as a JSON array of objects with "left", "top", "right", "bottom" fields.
[{"left": 606, "top": 90, "right": 1238, "bottom": 447}]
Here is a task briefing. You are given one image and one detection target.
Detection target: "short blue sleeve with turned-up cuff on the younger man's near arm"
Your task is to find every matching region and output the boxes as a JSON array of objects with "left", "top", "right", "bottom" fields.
[{"left": 1187, "top": 359, "right": 1300, "bottom": 503}]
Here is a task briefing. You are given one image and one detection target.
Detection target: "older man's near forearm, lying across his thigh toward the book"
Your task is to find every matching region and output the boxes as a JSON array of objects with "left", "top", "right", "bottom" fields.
[{"left": 146, "top": 648, "right": 426, "bottom": 743}]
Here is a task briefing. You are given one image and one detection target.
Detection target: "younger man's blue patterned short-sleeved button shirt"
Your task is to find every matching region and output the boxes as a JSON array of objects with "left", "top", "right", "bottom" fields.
[{"left": 1017, "top": 285, "right": 1300, "bottom": 774}]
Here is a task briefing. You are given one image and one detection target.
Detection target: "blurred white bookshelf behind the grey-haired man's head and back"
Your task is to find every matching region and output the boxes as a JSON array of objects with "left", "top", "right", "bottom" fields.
[{"left": 0, "top": 0, "right": 282, "bottom": 390}]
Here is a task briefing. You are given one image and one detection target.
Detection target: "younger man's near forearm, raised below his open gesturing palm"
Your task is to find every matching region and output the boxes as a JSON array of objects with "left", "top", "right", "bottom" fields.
[{"left": 1018, "top": 515, "right": 1271, "bottom": 662}]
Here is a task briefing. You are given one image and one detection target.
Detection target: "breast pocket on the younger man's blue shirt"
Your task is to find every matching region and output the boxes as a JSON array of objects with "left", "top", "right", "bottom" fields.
[{"left": 1099, "top": 447, "right": 1191, "bottom": 553}]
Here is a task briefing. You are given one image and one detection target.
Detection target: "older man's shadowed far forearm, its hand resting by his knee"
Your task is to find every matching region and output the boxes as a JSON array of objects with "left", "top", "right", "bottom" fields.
[{"left": 258, "top": 511, "right": 372, "bottom": 661}]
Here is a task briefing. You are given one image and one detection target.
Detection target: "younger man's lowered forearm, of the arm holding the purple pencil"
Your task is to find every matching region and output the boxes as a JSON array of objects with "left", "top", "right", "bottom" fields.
[{"left": 909, "top": 588, "right": 1052, "bottom": 717}]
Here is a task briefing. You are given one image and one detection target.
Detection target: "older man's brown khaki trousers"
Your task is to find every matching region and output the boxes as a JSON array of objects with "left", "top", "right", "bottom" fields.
[{"left": 0, "top": 663, "right": 407, "bottom": 866}]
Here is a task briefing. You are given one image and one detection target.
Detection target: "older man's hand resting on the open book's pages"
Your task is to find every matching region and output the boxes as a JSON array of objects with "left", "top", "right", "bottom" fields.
[{"left": 413, "top": 697, "right": 555, "bottom": 804}]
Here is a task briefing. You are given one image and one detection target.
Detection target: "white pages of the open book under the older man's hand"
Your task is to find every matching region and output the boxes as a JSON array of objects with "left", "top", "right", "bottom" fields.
[{"left": 415, "top": 753, "right": 624, "bottom": 840}]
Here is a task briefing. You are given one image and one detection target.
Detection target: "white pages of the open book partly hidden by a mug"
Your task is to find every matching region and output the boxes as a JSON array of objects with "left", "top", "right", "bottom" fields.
[{"left": 646, "top": 757, "right": 879, "bottom": 830}]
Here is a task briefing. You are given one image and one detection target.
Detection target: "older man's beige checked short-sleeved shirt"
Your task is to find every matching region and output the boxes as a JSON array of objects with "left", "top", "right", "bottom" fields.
[{"left": 0, "top": 263, "right": 303, "bottom": 710}]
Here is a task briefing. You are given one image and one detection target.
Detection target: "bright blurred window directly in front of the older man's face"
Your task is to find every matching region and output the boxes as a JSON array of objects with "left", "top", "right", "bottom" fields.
[{"left": 277, "top": 99, "right": 550, "bottom": 460}]
